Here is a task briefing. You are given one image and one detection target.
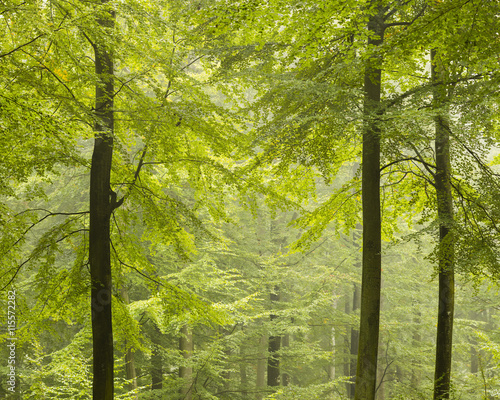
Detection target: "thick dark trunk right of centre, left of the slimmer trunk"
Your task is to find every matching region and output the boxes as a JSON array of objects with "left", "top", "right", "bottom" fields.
[{"left": 354, "top": 11, "right": 385, "bottom": 400}]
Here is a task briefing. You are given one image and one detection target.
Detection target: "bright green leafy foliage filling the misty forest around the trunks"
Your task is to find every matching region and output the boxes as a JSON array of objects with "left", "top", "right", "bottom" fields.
[{"left": 0, "top": 0, "right": 500, "bottom": 400}]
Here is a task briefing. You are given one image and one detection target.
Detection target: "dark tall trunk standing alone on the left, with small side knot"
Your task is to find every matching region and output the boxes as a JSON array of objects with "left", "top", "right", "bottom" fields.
[{"left": 89, "top": 0, "right": 116, "bottom": 400}]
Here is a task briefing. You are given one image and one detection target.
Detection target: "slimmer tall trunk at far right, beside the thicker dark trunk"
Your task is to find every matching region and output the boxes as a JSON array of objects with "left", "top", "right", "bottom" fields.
[{"left": 431, "top": 49, "right": 455, "bottom": 400}]
